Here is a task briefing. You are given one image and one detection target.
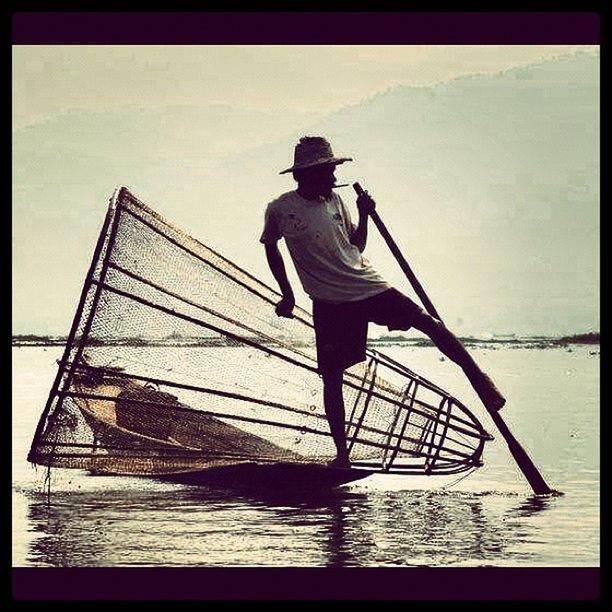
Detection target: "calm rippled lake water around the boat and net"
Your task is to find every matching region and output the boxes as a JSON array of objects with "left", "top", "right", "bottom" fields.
[{"left": 13, "top": 346, "right": 600, "bottom": 567}]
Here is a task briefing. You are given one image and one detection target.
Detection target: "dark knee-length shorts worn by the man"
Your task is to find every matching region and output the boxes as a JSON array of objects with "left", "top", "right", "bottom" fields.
[{"left": 312, "top": 289, "right": 425, "bottom": 374}]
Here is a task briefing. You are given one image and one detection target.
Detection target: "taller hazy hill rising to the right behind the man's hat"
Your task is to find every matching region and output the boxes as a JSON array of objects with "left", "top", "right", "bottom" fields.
[{"left": 220, "top": 53, "right": 600, "bottom": 333}]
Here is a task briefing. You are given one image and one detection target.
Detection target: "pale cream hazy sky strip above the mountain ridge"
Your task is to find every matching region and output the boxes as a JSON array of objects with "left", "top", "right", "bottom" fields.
[{"left": 13, "top": 45, "right": 585, "bottom": 127}]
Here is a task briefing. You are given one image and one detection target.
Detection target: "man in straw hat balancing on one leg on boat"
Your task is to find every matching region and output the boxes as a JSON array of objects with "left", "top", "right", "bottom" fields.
[{"left": 260, "top": 136, "right": 505, "bottom": 467}]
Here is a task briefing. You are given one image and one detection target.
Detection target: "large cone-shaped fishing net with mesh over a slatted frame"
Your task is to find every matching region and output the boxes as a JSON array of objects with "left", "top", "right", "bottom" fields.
[{"left": 29, "top": 188, "right": 489, "bottom": 474}]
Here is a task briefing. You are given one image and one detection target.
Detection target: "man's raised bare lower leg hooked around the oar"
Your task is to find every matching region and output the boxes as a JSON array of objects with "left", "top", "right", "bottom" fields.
[{"left": 414, "top": 313, "right": 506, "bottom": 410}]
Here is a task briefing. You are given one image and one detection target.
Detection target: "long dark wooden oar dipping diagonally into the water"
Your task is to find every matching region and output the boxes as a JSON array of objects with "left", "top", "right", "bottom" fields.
[{"left": 353, "top": 183, "right": 553, "bottom": 495}]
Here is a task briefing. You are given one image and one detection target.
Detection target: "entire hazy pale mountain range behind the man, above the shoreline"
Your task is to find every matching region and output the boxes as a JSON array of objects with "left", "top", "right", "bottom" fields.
[{"left": 13, "top": 53, "right": 600, "bottom": 336}]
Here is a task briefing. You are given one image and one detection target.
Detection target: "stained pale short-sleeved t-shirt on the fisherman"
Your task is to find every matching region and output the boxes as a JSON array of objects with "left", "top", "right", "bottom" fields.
[{"left": 260, "top": 190, "right": 390, "bottom": 303}]
